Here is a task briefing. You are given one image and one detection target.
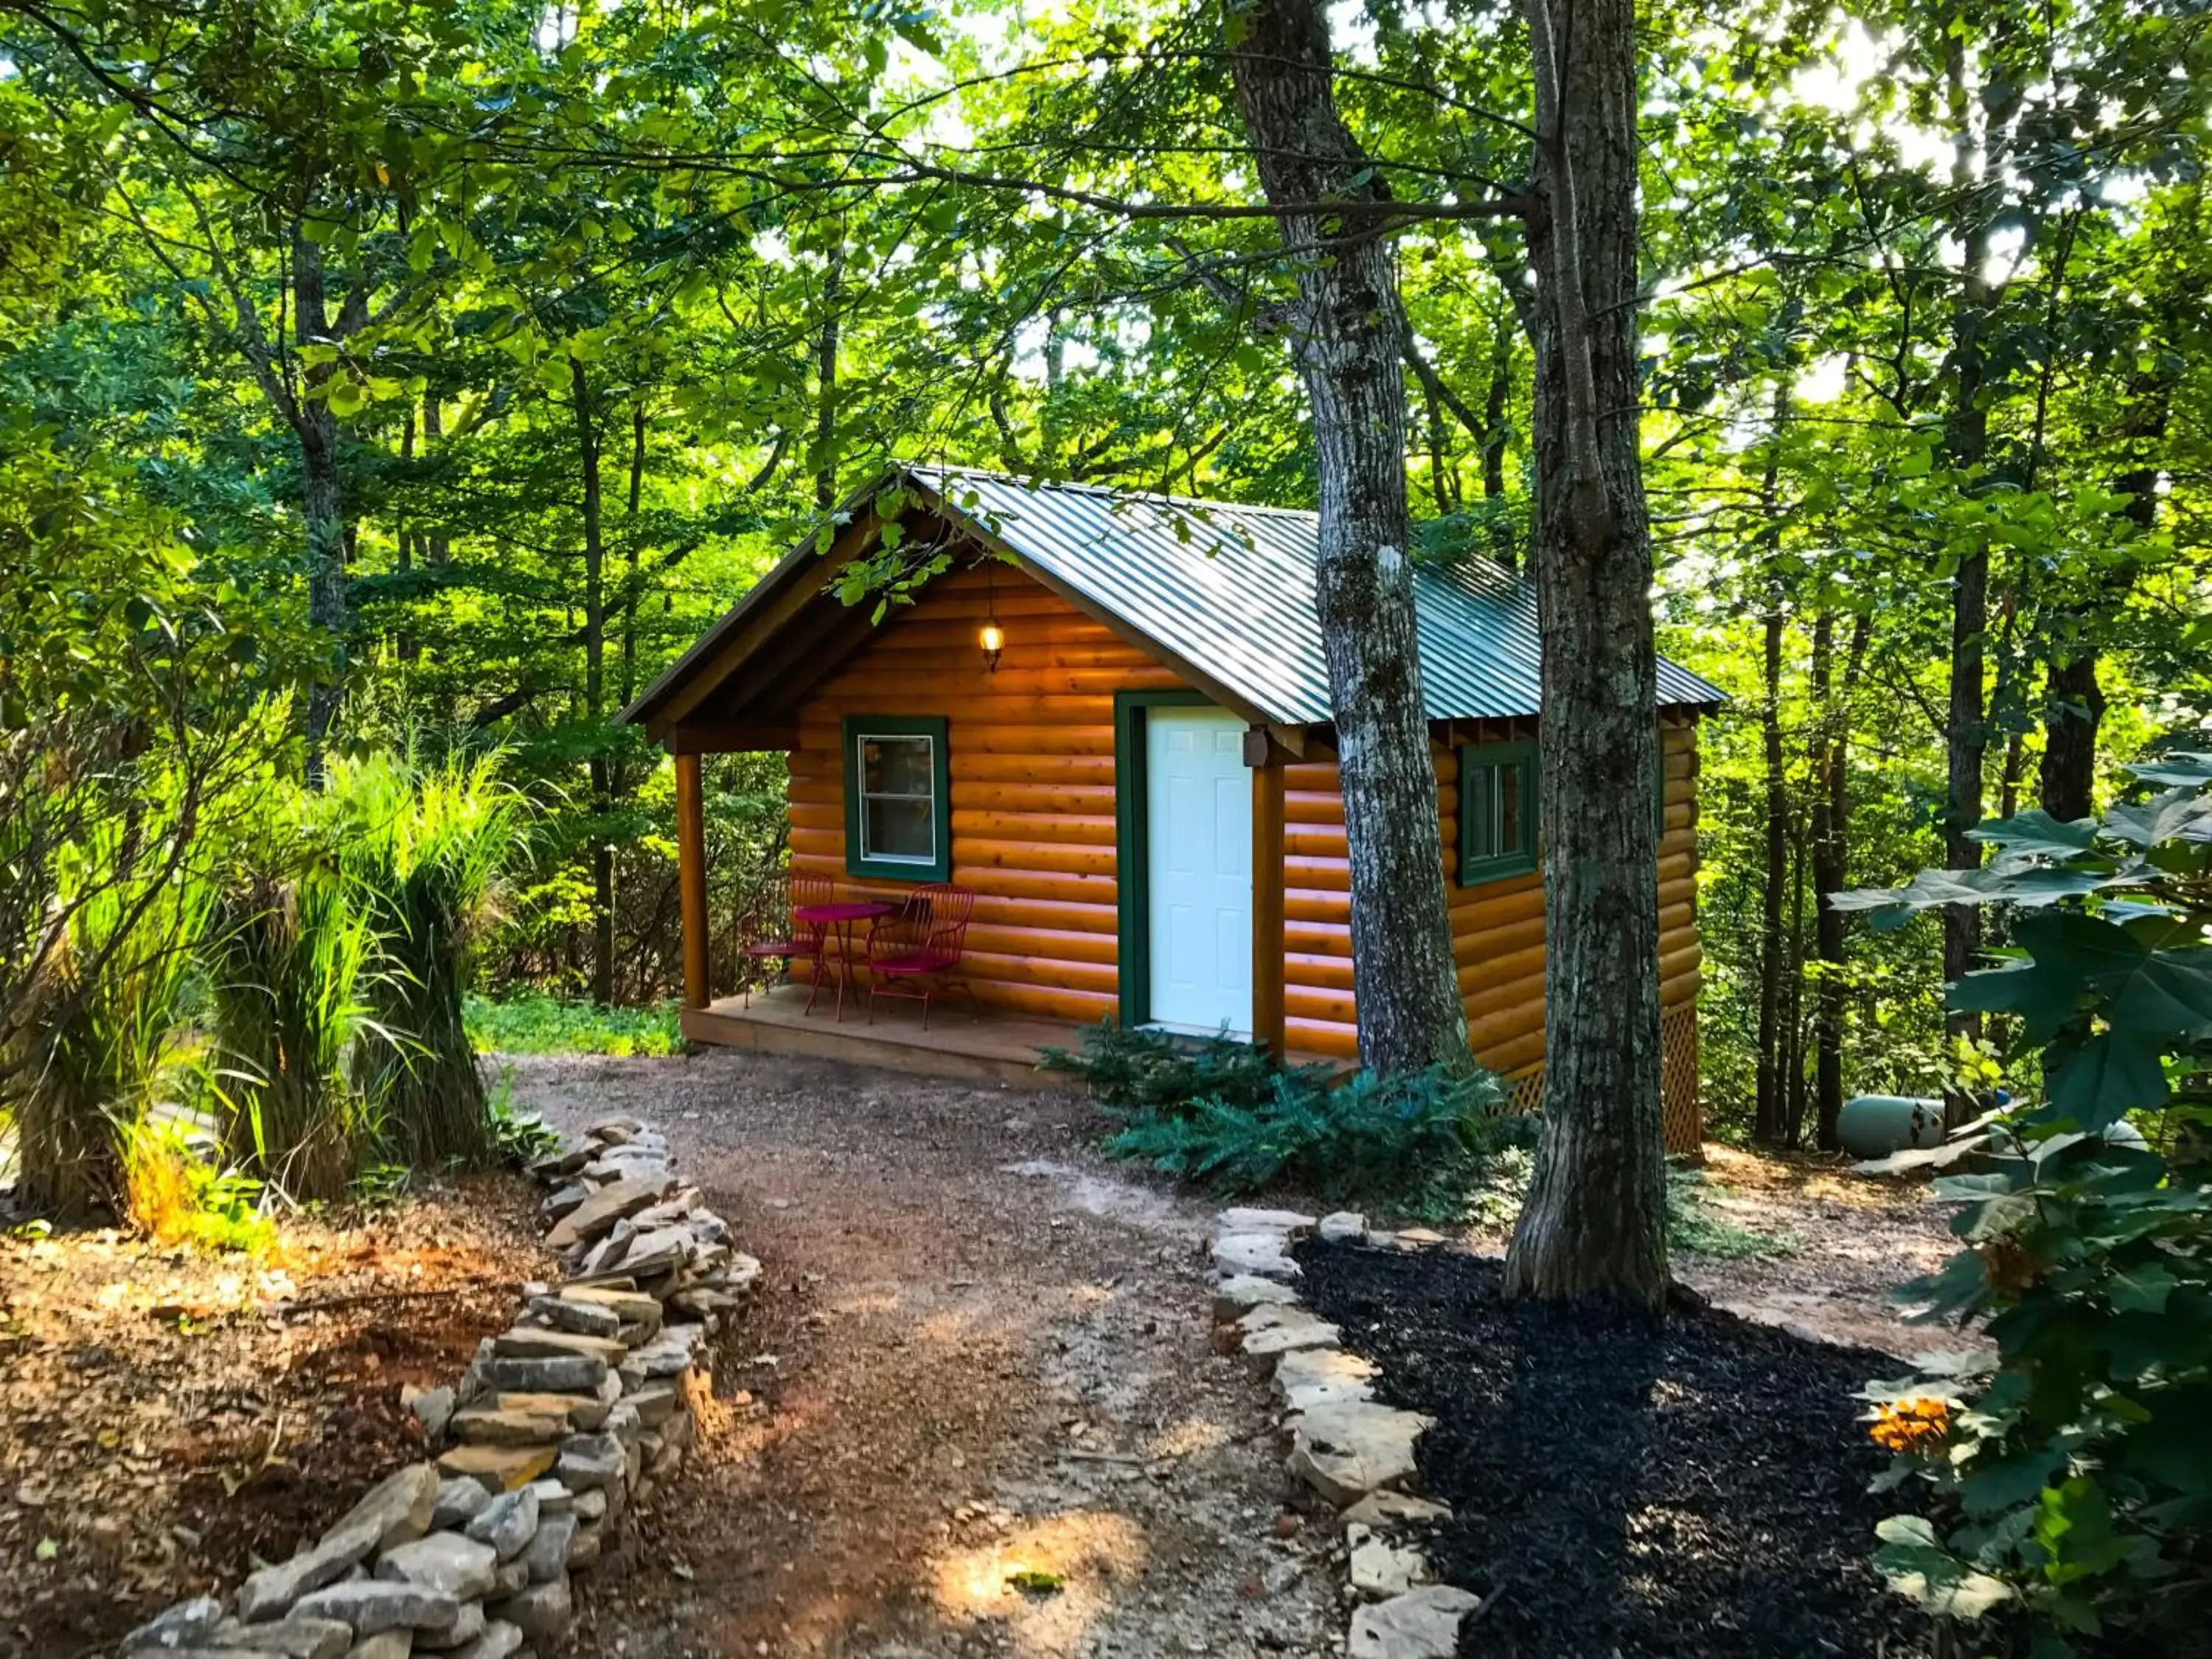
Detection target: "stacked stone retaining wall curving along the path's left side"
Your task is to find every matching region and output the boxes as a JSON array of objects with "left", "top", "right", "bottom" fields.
[{"left": 119, "top": 1117, "right": 761, "bottom": 1659}]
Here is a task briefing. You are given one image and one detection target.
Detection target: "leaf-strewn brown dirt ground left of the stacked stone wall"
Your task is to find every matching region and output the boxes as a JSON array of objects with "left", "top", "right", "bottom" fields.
[{"left": 0, "top": 1177, "right": 551, "bottom": 1659}]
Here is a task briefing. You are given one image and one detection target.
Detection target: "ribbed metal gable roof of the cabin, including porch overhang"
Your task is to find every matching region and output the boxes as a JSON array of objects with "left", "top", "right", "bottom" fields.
[{"left": 622, "top": 467, "right": 1723, "bottom": 752}]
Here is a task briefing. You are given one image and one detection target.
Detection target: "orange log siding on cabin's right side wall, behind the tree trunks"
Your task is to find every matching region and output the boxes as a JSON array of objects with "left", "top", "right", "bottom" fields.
[{"left": 1283, "top": 721, "right": 1703, "bottom": 1075}]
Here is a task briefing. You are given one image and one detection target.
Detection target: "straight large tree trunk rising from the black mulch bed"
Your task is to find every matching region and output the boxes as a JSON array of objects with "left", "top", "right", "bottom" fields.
[{"left": 1504, "top": 0, "right": 1668, "bottom": 1310}]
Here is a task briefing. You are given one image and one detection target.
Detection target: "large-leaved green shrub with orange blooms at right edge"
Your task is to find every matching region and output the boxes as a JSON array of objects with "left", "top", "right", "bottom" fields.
[{"left": 1845, "top": 757, "right": 2212, "bottom": 1655}]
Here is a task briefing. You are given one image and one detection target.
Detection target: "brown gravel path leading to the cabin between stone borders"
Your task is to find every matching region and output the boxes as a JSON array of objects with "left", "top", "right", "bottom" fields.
[{"left": 509, "top": 1051, "right": 1343, "bottom": 1659}]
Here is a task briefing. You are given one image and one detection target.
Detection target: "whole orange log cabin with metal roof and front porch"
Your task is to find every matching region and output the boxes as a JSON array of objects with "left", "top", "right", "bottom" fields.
[{"left": 624, "top": 467, "right": 1721, "bottom": 1152}]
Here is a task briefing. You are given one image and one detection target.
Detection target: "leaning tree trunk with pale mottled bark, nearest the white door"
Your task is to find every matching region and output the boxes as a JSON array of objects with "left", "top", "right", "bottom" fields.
[{"left": 1230, "top": 0, "right": 1469, "bottom": 1073}]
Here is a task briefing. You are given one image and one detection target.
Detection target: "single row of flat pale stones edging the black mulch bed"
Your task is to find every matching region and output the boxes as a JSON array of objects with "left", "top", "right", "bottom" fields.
[{"left": 1212, "top": 1210, "right": 1478, "bottom": 1659}]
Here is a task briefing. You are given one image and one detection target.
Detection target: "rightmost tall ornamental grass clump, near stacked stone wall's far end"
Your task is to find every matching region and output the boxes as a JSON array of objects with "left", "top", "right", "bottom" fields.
[{"left": 330, "top": 754, "right": 526, "bottom": 1168}]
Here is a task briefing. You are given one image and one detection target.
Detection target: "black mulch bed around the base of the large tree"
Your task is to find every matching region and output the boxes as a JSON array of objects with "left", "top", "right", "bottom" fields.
[{"left": 1298, "top": 1243, "right": 1933, "bottom": 1659}]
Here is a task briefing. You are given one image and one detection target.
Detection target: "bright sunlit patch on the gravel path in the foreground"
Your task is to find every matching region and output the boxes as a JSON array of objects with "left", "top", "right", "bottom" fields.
[{"left": 936, "top": 1509, "right": 1150, "bottom": 1657}]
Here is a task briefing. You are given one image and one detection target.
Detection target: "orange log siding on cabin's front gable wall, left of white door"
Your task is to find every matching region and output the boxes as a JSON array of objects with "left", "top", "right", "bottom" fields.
[{"left": 792, "top": 566, "right": 1181, "bottom": 1022}]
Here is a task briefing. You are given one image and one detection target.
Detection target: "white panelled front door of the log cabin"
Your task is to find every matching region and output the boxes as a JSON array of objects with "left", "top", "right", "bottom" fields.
[{"left": 1144, "top": 708, "right": 1252, "bottom": 1035}]
